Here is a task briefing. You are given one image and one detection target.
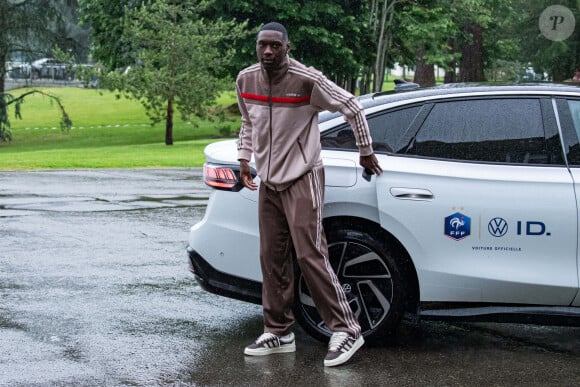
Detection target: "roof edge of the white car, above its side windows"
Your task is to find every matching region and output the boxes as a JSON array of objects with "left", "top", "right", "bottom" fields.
[{"left": 319, "top": 83, "right": 580, "bottom": 122}]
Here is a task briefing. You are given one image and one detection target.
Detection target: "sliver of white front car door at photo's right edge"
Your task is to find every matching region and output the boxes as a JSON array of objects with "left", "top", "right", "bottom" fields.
[{"left": 556, "top": 97, "right": 580, "bottom": 306}]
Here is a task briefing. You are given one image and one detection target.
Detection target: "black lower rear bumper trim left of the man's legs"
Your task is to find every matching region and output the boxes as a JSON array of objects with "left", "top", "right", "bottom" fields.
[{"left": 187, "top": 247, "right": 262, "bottom": 304}]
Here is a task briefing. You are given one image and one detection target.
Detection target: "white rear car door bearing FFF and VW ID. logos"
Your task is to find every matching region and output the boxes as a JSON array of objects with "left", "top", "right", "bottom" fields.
[{"left": 376, "top": 96, "right": 578, "bottom": 305}]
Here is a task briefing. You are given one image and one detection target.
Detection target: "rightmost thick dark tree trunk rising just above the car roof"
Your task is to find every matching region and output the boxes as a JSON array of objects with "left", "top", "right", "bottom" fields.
[{"left": 459, "top": 23, "right": 485, "bottom": 82}]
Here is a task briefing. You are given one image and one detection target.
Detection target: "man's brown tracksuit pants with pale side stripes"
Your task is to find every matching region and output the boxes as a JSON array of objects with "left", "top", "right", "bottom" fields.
[{"left": 259, "top": 167, "right": 360, "bottom": 337}]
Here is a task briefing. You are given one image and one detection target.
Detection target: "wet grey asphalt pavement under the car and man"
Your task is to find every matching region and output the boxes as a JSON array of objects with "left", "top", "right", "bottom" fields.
[{"left": 0, "top": 169, "right": 580, "bottom": 387}]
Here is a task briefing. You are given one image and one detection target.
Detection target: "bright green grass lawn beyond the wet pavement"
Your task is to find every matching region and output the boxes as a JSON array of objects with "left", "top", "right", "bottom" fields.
[{"left": 0, "top": 87, "right": 239, "bottom": 170}]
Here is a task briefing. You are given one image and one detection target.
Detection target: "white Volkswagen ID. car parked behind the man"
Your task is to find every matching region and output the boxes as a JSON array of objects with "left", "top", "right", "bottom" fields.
[{"left": 188, "top": 84, "right": 580, "bottom": 341}]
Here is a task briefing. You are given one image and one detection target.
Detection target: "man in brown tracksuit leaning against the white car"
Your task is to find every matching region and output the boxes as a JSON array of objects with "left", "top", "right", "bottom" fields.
[{"left": 236, "top": 22, "right": 382, "bottom": 366}]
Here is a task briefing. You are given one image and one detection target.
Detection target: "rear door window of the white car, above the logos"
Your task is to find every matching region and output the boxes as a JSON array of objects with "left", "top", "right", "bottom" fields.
[{"left": 401, "top": 98, "right": 562, "bottom": 164}]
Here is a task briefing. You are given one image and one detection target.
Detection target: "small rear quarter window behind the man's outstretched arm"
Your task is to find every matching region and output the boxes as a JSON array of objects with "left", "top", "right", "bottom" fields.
[{"left": 321, "top": 106, "right": 420, "bottom": 152}]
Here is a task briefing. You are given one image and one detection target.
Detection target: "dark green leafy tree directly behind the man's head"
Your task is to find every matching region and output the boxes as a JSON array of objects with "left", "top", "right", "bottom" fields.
[{"left": 207, "top": 0, "right": 375, "bottom": 91}]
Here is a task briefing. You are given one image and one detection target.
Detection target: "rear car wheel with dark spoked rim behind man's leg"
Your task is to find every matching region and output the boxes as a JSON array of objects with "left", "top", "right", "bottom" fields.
[{"left": 294, "top": 223, "right": 405, "bottom": 342}]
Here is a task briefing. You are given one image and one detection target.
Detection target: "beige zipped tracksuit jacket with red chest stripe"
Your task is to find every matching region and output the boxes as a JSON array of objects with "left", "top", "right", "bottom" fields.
[{"left": 236, "top": 57, "right": 373, "bottom": 191}]
